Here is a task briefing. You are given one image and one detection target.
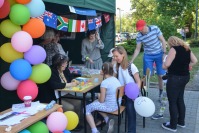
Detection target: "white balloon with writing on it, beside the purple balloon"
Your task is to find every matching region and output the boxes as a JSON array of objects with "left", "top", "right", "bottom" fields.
[{"left": 134, "top": 97, "right": 155, "bottom": 117}]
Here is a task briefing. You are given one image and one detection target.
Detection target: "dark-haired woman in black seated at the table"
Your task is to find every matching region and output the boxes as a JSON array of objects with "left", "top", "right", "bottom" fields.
[{"left": 38, "top": 54, "right": 81, "bottom": 114}]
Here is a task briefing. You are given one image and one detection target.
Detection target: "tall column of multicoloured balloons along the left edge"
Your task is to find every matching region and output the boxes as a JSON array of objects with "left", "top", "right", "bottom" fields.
[{"left": 0, "top": 0, "right": 51, "bottom": 100}]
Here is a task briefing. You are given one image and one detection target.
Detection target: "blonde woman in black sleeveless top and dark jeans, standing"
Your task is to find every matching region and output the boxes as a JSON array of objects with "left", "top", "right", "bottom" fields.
[{"left": 162, "top": 36, "right": 197, "bottom": 132}]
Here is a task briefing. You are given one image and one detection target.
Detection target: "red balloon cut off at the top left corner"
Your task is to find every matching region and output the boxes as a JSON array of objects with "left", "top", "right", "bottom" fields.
[{"left": 0, "top": 0, "right": 10, "bottom": 19}]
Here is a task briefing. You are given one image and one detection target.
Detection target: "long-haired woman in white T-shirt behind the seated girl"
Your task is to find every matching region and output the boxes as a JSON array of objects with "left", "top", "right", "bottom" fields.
[{"left": 113, "top": 46, "right": 141, "bottom": 133}]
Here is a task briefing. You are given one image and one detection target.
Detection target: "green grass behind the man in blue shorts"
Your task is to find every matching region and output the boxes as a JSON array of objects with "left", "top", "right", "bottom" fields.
[{"left": 128, "top": 47, "right": 199, "bottom": 82}]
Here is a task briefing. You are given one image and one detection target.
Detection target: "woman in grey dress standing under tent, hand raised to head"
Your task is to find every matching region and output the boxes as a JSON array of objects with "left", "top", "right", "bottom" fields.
[{"left": 81, "top": 30, "right": 104, "bottom": 70}]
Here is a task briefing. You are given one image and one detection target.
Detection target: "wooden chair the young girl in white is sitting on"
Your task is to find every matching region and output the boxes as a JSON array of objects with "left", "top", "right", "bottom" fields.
[{"left": 98, "top": 87, "right": 127, "bottom": 133}]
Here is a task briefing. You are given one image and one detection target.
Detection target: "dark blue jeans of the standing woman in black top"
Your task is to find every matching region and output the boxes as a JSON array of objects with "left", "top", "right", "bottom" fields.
[{"left": 166, "top": 75, "right": 190, "bottom": 129}]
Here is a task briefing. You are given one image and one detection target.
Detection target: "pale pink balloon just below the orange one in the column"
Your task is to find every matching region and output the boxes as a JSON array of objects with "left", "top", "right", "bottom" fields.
[{"left": 11, "top": 31, "right": 33, "bottom": 52}]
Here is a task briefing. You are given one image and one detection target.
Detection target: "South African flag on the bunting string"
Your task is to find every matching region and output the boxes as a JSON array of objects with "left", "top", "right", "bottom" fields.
[{"left": 57, "top": 16, "right": 68, "bottom": 31}]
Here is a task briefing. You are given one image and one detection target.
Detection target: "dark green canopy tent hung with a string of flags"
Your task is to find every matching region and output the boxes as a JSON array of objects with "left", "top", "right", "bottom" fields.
[{"left": 0, "top": 0, "right": 116, "bottom": 111}]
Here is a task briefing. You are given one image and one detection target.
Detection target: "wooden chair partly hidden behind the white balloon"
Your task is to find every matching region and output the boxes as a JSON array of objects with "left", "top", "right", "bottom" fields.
[{"left": 141, "top": 68, "right": 150, "bottom": 128}]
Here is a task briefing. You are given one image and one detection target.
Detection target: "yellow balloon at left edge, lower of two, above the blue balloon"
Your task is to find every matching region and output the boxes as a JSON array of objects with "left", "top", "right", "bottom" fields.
[{"left": 0, "top": 43, "right": 23, "bottom": 63}]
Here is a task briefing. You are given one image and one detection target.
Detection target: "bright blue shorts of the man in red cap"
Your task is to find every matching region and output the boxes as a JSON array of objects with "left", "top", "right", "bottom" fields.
[{"left": 143, "top": 52, "right": 165, "bottom": 75}]
